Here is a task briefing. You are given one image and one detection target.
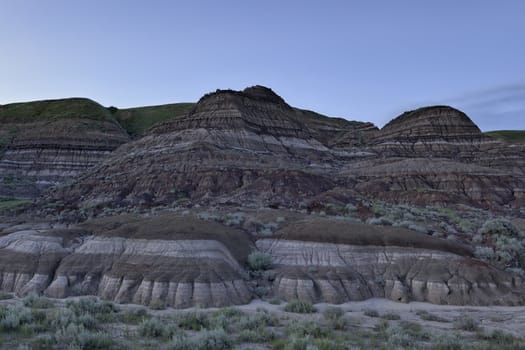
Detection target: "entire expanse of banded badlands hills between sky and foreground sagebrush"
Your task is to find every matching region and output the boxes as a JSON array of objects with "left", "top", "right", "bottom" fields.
[{"left": 0, "top": 86, "right": 525, "bottom": 308}]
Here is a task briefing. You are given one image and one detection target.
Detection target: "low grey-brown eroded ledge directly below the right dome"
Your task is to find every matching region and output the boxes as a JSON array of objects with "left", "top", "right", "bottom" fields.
[{"left": 343, "top": 158, "right": 525, "bottom": 208}]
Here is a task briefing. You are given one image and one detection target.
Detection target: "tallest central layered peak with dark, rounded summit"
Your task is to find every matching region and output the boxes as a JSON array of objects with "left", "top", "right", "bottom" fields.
[{"left": 48, "top": 87, "right": 356, "bottom": 211}]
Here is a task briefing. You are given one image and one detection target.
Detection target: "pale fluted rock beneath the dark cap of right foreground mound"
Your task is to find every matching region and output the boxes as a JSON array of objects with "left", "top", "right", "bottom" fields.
[{"left": 257, "top": 239, "right": 525, "bottom": 305}]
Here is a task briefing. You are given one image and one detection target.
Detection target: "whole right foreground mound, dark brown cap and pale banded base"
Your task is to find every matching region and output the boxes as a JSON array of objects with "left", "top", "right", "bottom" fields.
[{"left": 257, "top": 219, "right": 525, "bottom": 305}]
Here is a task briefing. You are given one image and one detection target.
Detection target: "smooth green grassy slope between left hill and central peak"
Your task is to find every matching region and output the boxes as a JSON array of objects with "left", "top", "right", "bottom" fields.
[{"left": 114, "top": 103, "right": 195, "bottom": 137}]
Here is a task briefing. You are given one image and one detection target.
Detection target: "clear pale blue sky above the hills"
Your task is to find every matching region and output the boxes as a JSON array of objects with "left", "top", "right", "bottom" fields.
[{"left": 0, "top": 0, "right": 525, "bottom": 130}]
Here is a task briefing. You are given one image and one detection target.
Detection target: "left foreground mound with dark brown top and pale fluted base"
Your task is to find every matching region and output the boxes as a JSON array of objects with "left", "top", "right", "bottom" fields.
[{"left": 0, "top": 216, "right": 252, "bottom": 307}]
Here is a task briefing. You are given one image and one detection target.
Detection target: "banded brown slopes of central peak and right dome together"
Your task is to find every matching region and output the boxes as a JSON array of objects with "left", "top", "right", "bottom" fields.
[{"left": 39, "top": 91, "right": 525, "bottom": 213}]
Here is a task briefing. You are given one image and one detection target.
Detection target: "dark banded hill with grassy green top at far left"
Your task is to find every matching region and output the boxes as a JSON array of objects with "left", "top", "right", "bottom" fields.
[{"left": 0, "top": 99, "right": 129, "bottom": 197}]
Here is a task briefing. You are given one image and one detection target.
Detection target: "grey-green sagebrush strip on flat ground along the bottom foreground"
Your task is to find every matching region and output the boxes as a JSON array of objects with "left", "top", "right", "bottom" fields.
[{"left": 0, "top": 297, "right": 525, "bottom": 350}]
